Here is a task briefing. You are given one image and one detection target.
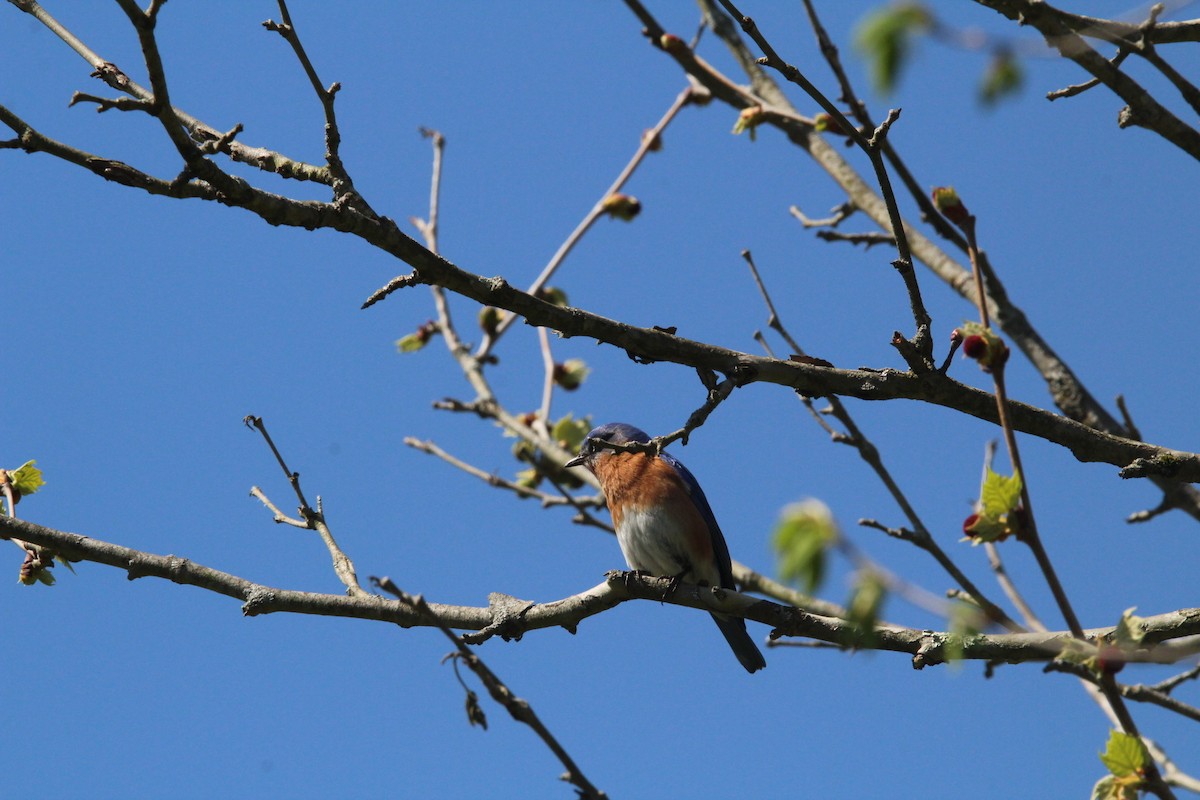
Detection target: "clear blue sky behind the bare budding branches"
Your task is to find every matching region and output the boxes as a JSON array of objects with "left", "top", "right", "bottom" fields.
[{"left": 0, "top": 1, "right": 1200, "bottom": 798}]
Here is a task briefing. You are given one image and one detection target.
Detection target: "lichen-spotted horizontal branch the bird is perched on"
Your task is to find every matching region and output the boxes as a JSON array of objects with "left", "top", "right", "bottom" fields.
[{"left": 7, "top": 517, "right": 1200, "bottom": 668}]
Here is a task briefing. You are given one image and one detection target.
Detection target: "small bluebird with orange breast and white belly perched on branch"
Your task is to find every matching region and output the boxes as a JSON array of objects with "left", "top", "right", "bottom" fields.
[{"left": 566, "top": 422, "right": 767, "bottom": 673}]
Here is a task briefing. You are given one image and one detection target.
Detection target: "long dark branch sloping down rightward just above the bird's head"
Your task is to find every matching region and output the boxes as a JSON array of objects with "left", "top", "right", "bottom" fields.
[{"left": 9, "top": 95, "right": 1200, "bottom": 482}]
